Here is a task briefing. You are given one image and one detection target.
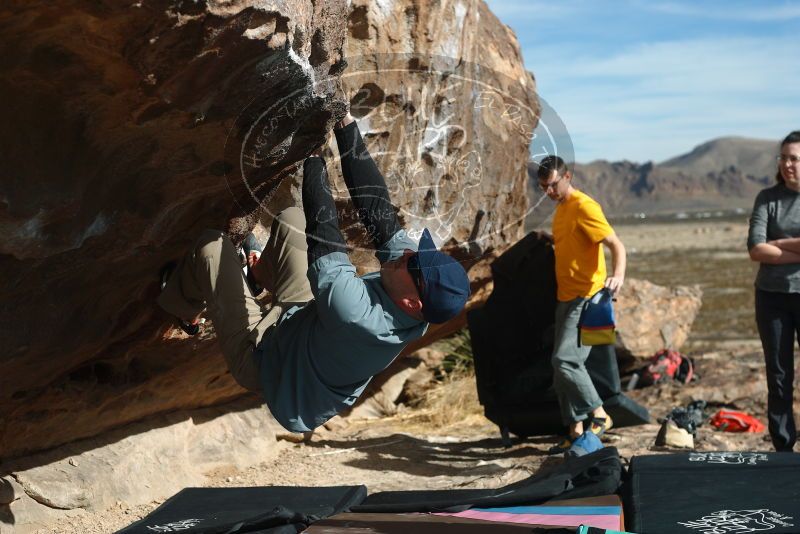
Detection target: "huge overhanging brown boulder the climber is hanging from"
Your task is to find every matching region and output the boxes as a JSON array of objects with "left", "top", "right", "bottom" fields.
[{"left": 0, "top": 0, "right": 538, "bottom": 457}]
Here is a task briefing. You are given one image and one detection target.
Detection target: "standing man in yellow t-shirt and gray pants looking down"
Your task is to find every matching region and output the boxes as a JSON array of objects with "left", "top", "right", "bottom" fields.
[{"left": 537, "top": 156, "right": 625, "bottom": 452}]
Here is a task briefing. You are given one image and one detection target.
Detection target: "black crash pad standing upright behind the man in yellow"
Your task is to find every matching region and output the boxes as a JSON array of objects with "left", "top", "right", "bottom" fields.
[{"left": 467, "top": 233, "right": 650, "bottom": 437}]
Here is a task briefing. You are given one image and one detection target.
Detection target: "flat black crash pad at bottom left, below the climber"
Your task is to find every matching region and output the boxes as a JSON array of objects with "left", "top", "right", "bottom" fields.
[{"left": 117, "top": 486, "right": 367, "bottom": 534}]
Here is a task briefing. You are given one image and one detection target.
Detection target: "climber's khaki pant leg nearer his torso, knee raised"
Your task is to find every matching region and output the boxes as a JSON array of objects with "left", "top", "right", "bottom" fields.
[{"left": 259, "top": 207, "right": 314, "bottom": 308}]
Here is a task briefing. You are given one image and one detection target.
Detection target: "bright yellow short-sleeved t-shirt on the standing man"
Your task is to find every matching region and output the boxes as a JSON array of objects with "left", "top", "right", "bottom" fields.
[{"left": 553, "top": 190, "right": 614, "bottom": 302}]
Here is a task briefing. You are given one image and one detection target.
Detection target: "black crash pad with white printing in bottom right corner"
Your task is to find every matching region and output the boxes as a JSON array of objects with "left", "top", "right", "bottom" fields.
[{"left": 623, "top": 452, "right": 800, "bottom": 534}]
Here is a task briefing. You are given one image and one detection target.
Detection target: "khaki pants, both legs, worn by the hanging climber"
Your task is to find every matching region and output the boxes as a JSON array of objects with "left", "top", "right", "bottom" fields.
[{"left": 158, "top": 208, "right": 314, "bottom": 391}]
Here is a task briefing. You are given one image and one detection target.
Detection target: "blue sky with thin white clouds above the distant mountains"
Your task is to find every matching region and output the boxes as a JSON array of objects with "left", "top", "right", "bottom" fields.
[{"left": 487, "top": 0, "right": 800, "bottom": 162}]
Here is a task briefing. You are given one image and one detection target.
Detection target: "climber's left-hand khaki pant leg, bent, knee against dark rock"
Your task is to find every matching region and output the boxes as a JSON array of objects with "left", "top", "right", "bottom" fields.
[{"left": 159, "top": 230, "right": 281, "bottom": 391}]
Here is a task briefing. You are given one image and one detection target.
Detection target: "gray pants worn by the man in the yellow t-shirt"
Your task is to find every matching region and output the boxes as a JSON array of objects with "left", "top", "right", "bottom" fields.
[{"left": 551, "top": 297, "right": 603, "bottom": 425}]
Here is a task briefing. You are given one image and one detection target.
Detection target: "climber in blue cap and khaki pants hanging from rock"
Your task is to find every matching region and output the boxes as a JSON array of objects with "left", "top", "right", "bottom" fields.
[{"left": 158, "top": 113, "right": 470, "bottom": 432}]
